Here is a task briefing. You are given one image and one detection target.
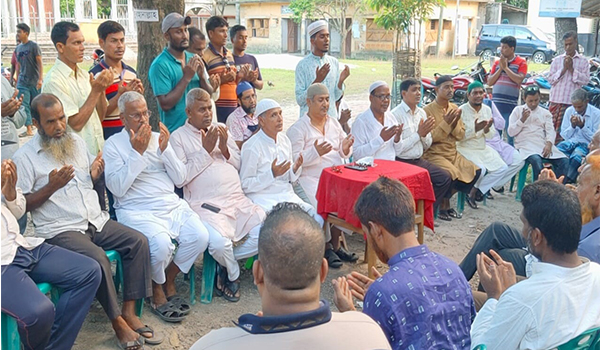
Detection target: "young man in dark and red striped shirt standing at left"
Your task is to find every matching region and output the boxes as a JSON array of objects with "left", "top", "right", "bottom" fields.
[{"left": 90, "top": 21, "right": 144, "bottom": 140}]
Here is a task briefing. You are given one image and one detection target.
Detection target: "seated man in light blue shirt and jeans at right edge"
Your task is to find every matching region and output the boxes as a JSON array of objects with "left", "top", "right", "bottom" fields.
[{"left": 556, "top": 89, "right": 600, "bottom": 183}]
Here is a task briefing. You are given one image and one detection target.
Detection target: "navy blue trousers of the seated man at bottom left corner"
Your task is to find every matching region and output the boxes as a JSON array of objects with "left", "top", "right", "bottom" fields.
[{"left": 2, "top": 243, "right": 102, "bottom": 350}]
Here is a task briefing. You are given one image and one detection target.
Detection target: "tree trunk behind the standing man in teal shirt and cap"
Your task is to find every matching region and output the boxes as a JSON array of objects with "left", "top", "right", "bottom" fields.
[{"left": 133, "top": 0, "right": 184, "bottom": 131}]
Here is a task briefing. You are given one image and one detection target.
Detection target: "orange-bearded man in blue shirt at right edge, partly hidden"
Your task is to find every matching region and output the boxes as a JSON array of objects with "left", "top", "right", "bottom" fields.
[{"left": 460, "top": 152, "right": 600, "bottom": 280}]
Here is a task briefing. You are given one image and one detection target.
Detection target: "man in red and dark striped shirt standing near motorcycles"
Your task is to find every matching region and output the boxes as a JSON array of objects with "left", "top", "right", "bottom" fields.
[{"left": 488, "top": 35, "right": 527, "bottom": 145}]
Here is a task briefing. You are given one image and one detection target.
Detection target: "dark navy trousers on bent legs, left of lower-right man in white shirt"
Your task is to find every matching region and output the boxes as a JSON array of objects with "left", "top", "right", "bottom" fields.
[{"left": 459, "top": 222, "right": 527, "bottom": 280}]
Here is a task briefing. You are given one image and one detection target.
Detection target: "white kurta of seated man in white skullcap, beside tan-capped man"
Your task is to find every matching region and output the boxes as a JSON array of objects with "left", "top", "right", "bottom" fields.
[{"left": 240, "top": 130, "right": 308, "bottom": 212}]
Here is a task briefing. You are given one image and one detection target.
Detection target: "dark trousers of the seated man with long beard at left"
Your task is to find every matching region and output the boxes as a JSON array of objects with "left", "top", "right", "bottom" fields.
[{"left": 46, "top": 220, "right": 152, "bottom": 320}]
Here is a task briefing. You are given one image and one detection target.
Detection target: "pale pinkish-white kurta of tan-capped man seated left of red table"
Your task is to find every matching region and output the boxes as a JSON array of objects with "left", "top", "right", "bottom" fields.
[{"left": 287, "top": 114, "right": 352, "bottom": 208}]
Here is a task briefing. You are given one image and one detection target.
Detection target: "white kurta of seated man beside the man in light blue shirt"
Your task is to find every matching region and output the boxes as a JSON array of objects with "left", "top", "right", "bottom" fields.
[{"left": 508, "top": 105, "right": 566, "bottom": 159}]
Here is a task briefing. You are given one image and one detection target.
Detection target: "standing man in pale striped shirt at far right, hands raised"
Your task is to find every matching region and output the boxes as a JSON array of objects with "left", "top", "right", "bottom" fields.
[{"left": 548, "top": 31, "right": 590, "bottom": 144}]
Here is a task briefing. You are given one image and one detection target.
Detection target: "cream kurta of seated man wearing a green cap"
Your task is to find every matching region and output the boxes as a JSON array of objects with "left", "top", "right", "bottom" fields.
[{"left": 456, "top": 103, "right": 506, "bottom": 172}]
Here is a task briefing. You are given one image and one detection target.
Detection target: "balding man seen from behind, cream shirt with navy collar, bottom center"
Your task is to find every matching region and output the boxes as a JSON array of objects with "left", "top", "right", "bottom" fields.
[{"left": 191, "top": 203, "right": 390, "bottom": 350}]
